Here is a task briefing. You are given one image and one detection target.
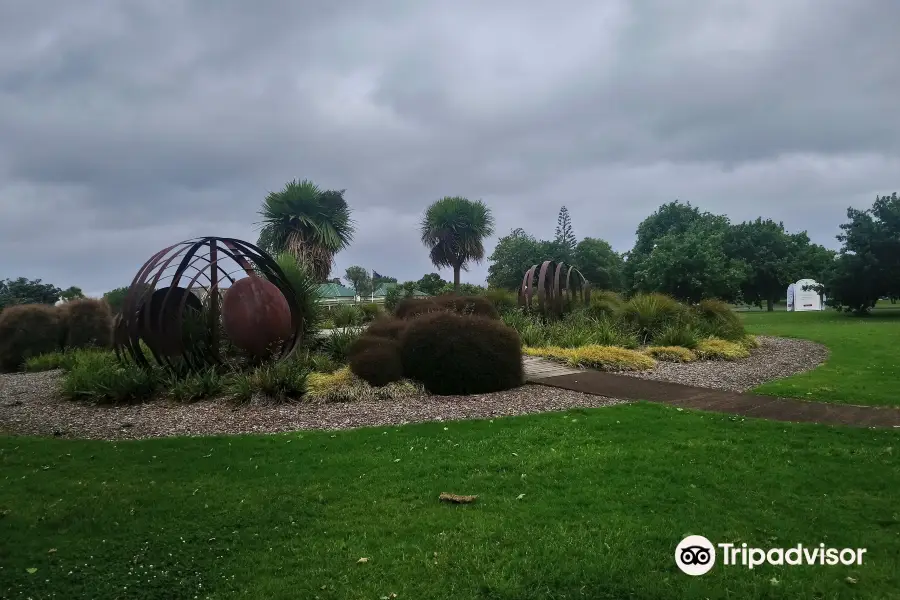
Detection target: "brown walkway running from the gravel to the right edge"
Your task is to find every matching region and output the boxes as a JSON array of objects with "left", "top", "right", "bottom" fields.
[{"left": 529, "top": 370, "right": 900, "bottom": 429}]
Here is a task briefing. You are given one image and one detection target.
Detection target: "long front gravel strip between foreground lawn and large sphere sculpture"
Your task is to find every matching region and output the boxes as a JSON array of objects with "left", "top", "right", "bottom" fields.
[{"left": 0, "top": 371, "right": 624, "bottom": 440}]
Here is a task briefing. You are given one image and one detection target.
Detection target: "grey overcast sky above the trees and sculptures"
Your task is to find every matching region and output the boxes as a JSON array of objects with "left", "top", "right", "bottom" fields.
[{"left": 0, "top": 0, "right": 900, "bottom": 294}]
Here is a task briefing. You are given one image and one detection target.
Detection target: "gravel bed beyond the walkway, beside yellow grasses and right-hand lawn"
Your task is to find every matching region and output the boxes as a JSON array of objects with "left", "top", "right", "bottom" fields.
[{"left": 619, "top": 336, "right": 828, "bottom": 392}]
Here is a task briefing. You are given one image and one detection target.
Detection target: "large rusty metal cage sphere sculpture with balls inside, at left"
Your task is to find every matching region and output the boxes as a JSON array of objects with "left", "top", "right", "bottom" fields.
[{"left": 114, "top": 237, "right": 303, "bottom": 370}]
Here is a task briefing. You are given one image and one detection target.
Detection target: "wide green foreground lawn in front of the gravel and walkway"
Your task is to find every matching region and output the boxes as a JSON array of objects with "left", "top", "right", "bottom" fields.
[{"left": 0, "top": 404, "right": 900, "bottom": 600}]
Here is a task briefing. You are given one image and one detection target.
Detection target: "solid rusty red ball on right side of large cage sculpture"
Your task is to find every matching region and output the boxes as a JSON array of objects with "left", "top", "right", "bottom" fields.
[{"left": 222, "top": 277, "right": 293, "bottom": 357}]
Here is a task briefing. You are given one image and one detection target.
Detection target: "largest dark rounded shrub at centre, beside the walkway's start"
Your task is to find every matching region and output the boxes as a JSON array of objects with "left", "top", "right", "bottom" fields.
[{"left": 401, "top": 312, "right": 524, "bottom": 395}]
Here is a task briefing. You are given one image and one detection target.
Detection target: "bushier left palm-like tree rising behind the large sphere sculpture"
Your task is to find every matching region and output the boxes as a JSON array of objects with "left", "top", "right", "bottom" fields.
[{"left": 257, "top": 179, "right": 355, "bottom": 281}]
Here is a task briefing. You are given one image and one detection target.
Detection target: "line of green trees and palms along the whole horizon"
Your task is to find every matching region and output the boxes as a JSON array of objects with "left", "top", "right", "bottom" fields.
[{"left": 0, "top": 180, "right": 900, "bottom": 313}]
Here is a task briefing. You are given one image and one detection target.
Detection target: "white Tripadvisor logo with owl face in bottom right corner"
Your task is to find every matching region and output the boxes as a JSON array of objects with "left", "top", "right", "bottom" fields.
[{"left": 675, "top": 535, "right": 866, "bottom": 576}]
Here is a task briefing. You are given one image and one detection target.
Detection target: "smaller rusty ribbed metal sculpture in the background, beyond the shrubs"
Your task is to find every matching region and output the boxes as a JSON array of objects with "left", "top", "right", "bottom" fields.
[{"left": 518, "top": 260, "right": 591, "bottom": 317}]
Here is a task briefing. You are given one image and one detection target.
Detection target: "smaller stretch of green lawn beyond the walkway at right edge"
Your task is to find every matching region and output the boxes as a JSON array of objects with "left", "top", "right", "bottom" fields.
[{"left": 742, "top": 308, "right": 900, "bottom": 406}]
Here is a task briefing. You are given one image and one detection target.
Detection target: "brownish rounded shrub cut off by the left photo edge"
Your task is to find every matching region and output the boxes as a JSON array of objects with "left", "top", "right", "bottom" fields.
[{"left": 0, "top": 304, "right": 63, "bottom": 371}]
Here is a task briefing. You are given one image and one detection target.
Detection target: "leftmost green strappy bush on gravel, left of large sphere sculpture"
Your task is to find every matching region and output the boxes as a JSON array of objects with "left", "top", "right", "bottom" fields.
[{"left": 62, "top": 352, "right": 165, "bottom": 404}]
